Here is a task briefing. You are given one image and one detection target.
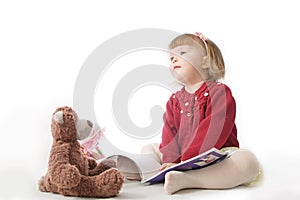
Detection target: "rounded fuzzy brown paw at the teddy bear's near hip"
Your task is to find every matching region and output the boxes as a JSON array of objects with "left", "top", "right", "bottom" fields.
[{"left": 49, "top": 163, "right": 81, "bottom": 188}]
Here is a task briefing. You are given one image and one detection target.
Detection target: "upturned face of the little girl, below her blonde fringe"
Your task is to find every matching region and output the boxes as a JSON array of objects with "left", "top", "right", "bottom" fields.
[{"left": 170, "top": 45, "right": 205, "bottom": 85}]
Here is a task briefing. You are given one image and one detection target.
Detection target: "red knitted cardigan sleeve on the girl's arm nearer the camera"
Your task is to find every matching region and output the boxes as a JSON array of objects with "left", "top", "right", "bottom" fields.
[{"left": 181, "top": 84, "right": 239, "bottom": 160}]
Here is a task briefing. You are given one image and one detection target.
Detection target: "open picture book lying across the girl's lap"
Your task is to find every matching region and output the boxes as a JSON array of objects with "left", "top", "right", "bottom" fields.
[{"left": 107, "top": 148, "right": 228, "bottom": 184}]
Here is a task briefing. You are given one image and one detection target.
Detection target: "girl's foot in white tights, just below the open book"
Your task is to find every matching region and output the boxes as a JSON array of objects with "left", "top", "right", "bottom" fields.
[{"left": 164, "top": 171, "right": 184, "bottom": 194}]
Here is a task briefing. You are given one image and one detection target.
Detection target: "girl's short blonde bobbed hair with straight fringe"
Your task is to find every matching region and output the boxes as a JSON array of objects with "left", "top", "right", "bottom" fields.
[{"left": 169, "top": 33, "right": 225, "bottom": 80}]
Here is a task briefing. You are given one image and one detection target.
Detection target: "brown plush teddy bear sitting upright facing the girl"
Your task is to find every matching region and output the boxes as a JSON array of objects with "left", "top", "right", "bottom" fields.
[{"left": 39, "top": 107, "right": 124, "bottom": 197}]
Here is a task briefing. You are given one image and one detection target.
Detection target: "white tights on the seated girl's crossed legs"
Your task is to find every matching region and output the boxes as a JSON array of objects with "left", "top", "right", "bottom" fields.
[{"left": 142, "top": 144, "right": 260, "bottom": 194}]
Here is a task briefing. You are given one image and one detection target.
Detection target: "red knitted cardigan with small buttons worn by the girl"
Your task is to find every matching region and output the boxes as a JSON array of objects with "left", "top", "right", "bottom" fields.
[{"left": 159, "top": 82, "right": 239, "bottom": 163}]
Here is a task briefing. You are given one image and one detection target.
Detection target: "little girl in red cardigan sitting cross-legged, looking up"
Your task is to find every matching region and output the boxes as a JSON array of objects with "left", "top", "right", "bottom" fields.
[{"left": 142, "top": 32, "right": 260, "bottom": 194}]
